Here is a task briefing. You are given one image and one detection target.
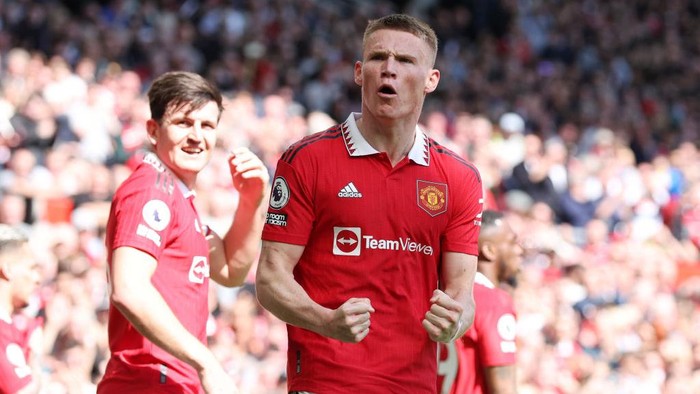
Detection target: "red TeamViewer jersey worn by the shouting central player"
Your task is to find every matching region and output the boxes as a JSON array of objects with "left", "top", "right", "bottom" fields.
[{"left": 263, "top": 114, "right": 482, "bottom": 393}]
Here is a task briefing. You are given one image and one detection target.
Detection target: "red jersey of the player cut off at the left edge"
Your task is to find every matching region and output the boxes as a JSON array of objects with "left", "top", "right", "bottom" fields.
[{"left": 0, "top": 316, "right": 32, "bottom": 394}]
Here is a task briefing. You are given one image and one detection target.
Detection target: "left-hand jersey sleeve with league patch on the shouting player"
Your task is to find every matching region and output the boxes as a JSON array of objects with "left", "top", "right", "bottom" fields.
[{"left": 262, "top": 155, "right": 315, "bottom": 245}]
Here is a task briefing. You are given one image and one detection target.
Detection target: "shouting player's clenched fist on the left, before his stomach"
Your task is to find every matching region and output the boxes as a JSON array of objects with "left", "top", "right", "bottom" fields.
[{"left": 327, "top": 298, "right": 374, "bottom": 343}]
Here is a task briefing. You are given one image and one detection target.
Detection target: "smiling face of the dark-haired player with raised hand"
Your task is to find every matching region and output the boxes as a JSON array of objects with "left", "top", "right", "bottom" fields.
[{"left": 146, "top": 101, "right": 219, "bottom": 188}]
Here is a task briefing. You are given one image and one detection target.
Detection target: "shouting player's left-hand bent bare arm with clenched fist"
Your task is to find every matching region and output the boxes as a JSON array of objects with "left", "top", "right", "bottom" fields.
[{"left": 256, "top": 241, "right": 374, "bottom": 342}]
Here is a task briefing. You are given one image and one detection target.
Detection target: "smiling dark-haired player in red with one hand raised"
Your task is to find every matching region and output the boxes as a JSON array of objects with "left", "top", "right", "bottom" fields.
[{"left": 97, "top": 72, "right": 269, "bottom": 393}]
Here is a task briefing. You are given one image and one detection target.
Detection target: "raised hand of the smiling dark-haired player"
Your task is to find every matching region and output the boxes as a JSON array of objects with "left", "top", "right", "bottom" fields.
[{"left": 228, "top": 147, "right": 270, "bottom": 205}]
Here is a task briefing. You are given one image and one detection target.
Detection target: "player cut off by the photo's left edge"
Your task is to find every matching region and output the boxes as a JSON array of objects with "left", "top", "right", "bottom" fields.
[{"left": 0, "top": 224, "right": 41, "bottom": 394}]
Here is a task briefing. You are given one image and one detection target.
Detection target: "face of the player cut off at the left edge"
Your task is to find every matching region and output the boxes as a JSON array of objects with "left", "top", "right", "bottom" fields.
[{"left": 0, "top": 243, "right": 41, "bottom": 310}]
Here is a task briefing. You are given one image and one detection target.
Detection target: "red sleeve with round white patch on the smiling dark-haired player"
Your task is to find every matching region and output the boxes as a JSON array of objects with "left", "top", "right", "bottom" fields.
[{"left": 110, "top": 173, "right": 177, "bottom": 260}]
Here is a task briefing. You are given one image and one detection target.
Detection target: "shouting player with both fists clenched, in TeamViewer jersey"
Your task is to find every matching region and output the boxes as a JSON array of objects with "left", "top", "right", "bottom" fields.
[{"left": 256, "top": 14, "right": 482, "bottom": 393}]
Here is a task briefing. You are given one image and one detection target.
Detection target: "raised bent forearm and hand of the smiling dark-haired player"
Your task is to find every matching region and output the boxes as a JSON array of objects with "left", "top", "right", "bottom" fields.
[{"left": 207, "top": 148, "right": 270, "bottom": 287}]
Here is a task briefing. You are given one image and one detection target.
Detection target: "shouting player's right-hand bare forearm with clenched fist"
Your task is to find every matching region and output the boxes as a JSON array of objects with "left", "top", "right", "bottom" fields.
[{"left": 423, "top": 252, "right": 477, "bottom": 342}]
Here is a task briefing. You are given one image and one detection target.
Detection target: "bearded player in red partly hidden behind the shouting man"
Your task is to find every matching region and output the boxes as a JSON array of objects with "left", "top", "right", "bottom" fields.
[{"left": 438, "top": 210, "right": 523, "bottom": 394}]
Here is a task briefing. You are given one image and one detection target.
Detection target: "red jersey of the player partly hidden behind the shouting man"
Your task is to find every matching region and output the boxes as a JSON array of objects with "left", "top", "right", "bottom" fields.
[{"left": 438, "top": 273, "right": 516, "bottom": 394}]
